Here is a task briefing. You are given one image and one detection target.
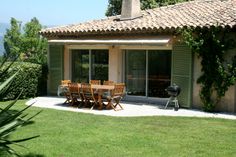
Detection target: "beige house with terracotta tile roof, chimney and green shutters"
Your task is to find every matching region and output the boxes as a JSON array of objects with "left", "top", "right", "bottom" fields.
[{"left": 40, "top": 0, "right": 236, "bottom": 112}]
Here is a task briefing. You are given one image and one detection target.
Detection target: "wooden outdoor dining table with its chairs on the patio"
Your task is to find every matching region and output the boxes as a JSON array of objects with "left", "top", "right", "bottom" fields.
[{"left": 58, "top": 80, "right": 125, "bottom": 111}]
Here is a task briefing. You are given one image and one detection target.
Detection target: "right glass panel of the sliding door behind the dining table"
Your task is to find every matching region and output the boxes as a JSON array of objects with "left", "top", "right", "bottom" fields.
[{"left": 91, "top": 50, "right": 109, "bottom": 82}]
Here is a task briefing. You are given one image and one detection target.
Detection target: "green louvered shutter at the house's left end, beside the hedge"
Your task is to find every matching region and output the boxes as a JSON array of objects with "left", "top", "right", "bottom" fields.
[{"left": 48, "top": 45, "right": 64, "bottom": 95}]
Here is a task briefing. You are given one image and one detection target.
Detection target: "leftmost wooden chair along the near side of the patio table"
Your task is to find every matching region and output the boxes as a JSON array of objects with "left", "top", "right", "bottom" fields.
[{"left": 68, "top": 83, "right": 80, "bottom": 106}]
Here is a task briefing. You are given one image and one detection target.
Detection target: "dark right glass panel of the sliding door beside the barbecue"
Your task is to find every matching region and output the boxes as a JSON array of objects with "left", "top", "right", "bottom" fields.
[{"left": 148, "top": 50, "right": 171, "bottom": 98}]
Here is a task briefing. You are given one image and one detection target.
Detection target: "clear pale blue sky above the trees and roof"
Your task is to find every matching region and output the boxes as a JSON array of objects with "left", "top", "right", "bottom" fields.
[{"left": 0, "top": 0, "right": 108, "bottom": 26}]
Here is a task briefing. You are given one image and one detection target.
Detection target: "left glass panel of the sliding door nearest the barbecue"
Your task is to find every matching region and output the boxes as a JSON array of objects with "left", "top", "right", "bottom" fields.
[{"left": 125, "top": 50, "right": 146, "bottom": 96}]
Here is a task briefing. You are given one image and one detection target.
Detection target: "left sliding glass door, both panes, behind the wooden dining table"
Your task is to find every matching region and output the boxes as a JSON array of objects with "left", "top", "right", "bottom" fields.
[{"left": 71, "top": 50, "right": 108, "bottom": 82}]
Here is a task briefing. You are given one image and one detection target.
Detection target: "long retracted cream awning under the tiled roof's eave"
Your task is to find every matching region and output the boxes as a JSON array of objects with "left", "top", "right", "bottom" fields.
[{"left": 48, "top": 38, "right": 171, "bottom": 45}]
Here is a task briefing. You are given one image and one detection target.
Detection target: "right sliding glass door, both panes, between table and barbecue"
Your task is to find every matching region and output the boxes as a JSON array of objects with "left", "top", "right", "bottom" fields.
[{"left": 125, "top": 50, "right": 171, "bottom": 98}]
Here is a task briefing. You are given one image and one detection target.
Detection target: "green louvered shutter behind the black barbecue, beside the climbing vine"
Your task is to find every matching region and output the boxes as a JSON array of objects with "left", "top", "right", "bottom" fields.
[{"left": 171, "top": 44, "right": 193, "bottom": 108}]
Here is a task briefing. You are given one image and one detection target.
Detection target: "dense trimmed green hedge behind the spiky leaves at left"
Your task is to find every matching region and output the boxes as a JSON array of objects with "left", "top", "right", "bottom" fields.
[{"left": 0, "top": 62, "right": 42, "bottom": 100}]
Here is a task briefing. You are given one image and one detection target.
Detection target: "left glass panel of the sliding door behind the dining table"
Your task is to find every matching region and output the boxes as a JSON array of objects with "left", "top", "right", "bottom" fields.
[{"left": 72, "top": 50, "right": 89, "bottom": 82}]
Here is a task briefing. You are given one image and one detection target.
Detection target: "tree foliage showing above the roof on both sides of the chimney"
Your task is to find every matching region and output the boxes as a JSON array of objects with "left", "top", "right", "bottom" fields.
[{"left": 106, "top": 0, "right": 190, "bottom": 16}]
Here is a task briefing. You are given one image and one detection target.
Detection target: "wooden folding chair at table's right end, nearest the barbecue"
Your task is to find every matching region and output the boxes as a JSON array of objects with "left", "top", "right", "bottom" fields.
[{"left": 107, "top": 83, "right": 125, "bottom": 111}]
